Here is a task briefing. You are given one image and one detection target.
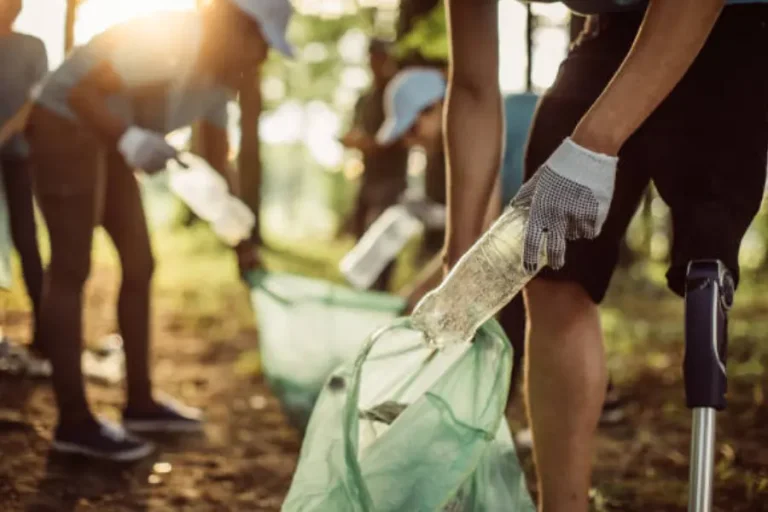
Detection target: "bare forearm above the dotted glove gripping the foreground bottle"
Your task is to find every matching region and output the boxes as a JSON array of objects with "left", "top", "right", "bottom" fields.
[{"left": 572, "top": 0, "right": 725, "bottom": 156}]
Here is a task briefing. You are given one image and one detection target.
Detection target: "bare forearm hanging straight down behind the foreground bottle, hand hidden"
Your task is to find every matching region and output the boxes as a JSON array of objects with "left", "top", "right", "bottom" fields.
[{"left": 445, "top": 0, "right": 504, "bottom": 264}]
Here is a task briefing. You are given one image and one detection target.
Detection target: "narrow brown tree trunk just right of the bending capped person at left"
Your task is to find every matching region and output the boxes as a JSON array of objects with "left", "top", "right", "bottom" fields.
[{"left": 237, "top": 70, "right": 262, "bottom": 243}]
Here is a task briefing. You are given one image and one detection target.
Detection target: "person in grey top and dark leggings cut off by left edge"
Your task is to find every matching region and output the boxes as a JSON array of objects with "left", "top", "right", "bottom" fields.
[{"left": 0, "top": 0, "right": 50, "bottom": 376}]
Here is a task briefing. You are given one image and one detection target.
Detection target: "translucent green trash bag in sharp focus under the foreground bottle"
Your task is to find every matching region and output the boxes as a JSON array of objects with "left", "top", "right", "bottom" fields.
[{"left": 282, "top": 320, "right": 535, "bottom": 512}]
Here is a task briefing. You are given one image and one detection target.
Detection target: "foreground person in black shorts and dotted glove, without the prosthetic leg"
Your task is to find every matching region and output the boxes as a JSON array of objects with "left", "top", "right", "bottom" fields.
[{"left": 446, "top": 0, "right": 768, "bottom": 512}]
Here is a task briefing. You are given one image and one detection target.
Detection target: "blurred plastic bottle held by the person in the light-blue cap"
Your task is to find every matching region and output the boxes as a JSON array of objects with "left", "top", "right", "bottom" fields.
[{"left": 339, "top": 205, "right": 422, "bottom": 290}]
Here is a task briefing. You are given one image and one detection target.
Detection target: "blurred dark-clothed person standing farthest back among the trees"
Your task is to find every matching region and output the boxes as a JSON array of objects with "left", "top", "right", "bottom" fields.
[{"left": 341, "top": 39, "right": 408, "bottom": 290}]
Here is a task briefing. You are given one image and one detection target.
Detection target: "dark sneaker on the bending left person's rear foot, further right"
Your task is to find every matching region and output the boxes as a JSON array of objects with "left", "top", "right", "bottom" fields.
[{"left": 123, "top": 397, "right": 203, "bottom": 434}]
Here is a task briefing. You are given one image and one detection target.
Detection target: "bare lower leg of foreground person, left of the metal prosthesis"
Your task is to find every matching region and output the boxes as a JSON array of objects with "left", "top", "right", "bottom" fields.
[{"left": 526, "top": 279, "right": 606, "bottom": 512}]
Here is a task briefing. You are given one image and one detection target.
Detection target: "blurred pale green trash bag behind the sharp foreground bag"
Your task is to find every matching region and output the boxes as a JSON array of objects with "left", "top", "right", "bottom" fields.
[{"left": 248, "top": 272, "right": 405, "bottom": 430}]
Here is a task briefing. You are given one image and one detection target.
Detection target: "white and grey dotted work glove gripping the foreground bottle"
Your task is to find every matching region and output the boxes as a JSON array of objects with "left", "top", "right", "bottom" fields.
[{"left": 512, "top": 138, "right": 618, "bottom": 272}]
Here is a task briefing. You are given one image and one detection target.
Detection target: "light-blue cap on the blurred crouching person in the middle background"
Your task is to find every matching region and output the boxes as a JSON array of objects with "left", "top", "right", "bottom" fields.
[{"left": 376, "top": 68, "right": 446, "bottom": 145}]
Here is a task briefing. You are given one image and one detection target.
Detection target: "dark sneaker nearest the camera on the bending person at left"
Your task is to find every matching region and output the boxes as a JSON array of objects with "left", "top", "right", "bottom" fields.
[{"left": 51, "top": 420, "right": 154, "bottom": 462}]
